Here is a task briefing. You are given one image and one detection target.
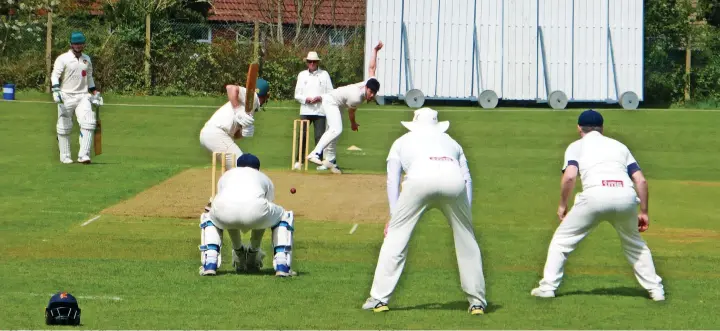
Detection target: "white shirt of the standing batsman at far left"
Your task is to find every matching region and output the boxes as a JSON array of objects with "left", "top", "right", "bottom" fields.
[{"left": 50, "top": 50, "right": 95, "bottom": 93}]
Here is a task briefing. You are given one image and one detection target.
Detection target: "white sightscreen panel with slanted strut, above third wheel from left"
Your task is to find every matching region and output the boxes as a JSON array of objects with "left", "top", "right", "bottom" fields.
[{"left": 538, "top": 0, "right": 573, "bottom": 100}]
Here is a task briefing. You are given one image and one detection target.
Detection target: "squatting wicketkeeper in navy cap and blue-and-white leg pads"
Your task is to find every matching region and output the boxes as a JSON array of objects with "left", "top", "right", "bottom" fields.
[{"left": 200, "top": 154, "right": 294, "bottom": 277}]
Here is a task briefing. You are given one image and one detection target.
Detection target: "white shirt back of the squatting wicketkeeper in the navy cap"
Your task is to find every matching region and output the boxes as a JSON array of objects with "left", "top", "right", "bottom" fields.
[{"left": 216, "top": 167, "right": 275, "bottom": 202}]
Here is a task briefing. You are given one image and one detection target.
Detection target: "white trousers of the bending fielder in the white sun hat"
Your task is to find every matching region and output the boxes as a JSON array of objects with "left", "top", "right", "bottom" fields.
[{"left": 370, "top": 161, "right": 487, "bottom": 307}]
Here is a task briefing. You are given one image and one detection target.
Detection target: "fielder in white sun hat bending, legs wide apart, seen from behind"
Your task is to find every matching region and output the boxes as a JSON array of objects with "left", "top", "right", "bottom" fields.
[{"left": 362, "top": 108, "right": 487, "bottom": 315}]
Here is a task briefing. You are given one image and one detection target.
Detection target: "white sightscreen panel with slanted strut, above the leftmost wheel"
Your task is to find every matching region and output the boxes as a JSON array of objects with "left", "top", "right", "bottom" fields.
[{"left": 401, "top": 0, "right": 438, "bottom": 96}]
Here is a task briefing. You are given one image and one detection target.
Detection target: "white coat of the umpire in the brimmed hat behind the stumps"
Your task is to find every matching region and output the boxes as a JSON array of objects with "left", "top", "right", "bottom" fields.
[{"left": 295, "top": 68, "right": 333, "bottom": 116}]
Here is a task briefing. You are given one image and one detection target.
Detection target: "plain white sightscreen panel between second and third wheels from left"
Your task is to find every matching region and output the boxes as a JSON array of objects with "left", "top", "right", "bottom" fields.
[{"left": 503, "top": 0, "right": 538, "bottom": 100}]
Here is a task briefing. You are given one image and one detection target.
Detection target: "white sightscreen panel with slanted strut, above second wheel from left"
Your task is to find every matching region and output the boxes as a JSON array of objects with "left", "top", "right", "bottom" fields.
[{"left": 471, "top": 0, "right": 503, "bottom": 98}]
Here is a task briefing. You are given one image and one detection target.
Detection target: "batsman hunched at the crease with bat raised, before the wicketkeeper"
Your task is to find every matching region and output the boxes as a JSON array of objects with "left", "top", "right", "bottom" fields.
[{"left": 200, "top": 78, "right": 270, "bottom": 169}]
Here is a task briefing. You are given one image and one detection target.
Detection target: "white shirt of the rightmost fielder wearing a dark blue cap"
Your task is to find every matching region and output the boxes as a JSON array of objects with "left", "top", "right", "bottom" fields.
[{"left": 562, "top": 131, "right": 640, "bottom": 190}]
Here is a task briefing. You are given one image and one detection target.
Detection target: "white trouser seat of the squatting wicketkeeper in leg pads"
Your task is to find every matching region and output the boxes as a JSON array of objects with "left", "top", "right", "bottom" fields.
[{"left": 210, "top": 194, "right": 285, "bottom": 232}]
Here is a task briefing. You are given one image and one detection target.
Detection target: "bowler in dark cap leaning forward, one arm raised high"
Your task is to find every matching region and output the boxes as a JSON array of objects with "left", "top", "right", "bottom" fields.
[{"left": 307, "top": 42, "right": 383, "bottom": 173}]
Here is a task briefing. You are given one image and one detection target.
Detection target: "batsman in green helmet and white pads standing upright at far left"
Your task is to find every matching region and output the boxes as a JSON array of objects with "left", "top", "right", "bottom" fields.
[{"left": 50, "top": 32, "right": 103, "bottom": 164}]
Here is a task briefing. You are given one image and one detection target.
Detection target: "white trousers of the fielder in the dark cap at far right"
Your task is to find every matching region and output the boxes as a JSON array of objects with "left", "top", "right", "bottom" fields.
[{"left": 540, "top": 187, "right": 664, "bottom": 294}]
